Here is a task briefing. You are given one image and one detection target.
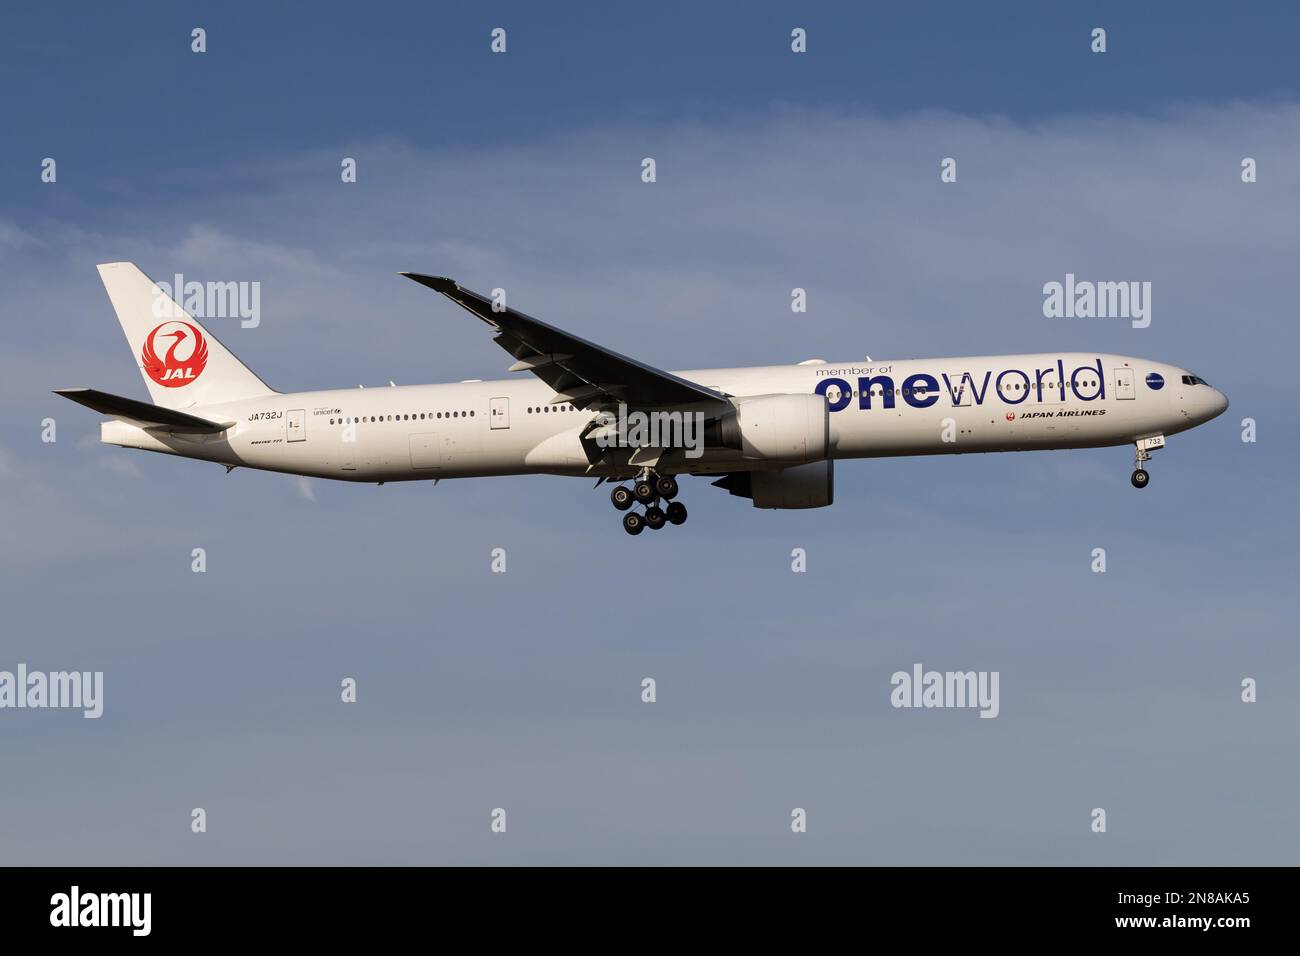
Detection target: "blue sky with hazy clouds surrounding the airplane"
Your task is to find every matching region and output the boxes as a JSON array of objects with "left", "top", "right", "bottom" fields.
[{"left": 0, "top": 4, "right": 1300, "bottom": 864}]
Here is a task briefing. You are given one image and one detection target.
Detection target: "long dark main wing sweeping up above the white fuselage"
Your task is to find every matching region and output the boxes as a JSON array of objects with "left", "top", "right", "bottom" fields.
[{"left": 400, "top": 272, "right": 727, "bottom": 408}]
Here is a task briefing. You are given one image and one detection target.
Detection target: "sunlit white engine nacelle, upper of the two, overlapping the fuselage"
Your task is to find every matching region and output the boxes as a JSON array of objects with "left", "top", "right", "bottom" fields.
[{"left": 720, "top": 395, "right": 831, "bottom": 462}]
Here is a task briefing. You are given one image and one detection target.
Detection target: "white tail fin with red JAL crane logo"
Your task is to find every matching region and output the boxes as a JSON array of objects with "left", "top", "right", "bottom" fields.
[{"left": 96, "top": 263, "right": 276, "bottom": 408}]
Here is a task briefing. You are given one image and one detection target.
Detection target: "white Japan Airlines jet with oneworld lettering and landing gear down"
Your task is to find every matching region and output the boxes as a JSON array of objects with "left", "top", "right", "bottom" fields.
[{"left": 56, "top": 263, "right": 1227, "bottom": 535}]
